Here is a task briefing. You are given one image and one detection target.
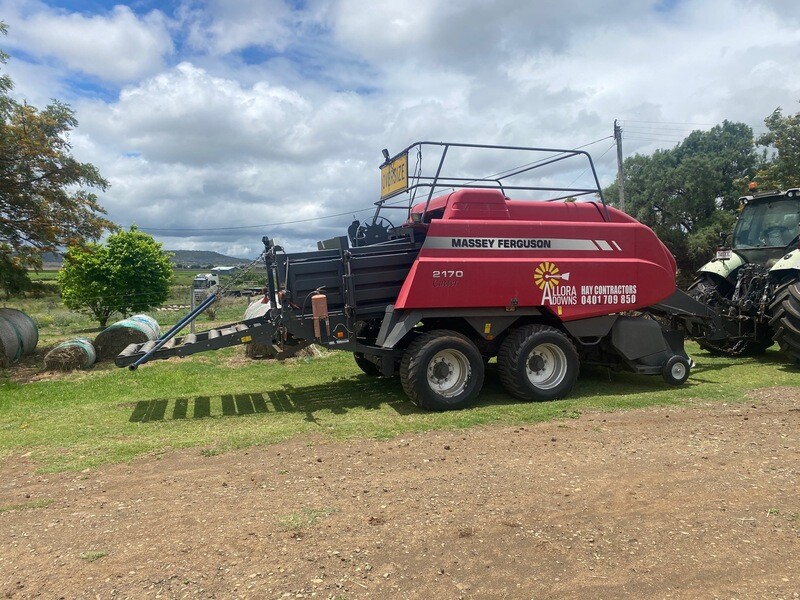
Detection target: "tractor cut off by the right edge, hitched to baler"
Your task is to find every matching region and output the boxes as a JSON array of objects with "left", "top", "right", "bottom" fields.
[{"left": 688, "top": 189, "right": 800, "bottom": 362}]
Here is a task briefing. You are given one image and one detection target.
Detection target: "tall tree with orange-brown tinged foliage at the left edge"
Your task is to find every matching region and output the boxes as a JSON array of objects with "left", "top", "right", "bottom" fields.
[{"left": 0, "top": 22, "right": 114, "bottom": 293}]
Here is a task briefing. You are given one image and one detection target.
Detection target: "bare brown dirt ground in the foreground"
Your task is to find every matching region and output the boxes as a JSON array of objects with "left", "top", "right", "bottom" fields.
[{"left": 0, "top": 388, "right": 800, "bottom": 599}]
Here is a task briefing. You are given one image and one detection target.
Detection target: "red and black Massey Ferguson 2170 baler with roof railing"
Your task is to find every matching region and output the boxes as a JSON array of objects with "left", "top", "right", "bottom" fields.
[{"left": 116, "top": 142, "right": 722, "bottom": 410}]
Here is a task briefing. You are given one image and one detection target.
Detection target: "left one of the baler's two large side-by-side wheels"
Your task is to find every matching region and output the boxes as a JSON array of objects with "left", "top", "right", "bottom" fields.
[{"left": 400, "top": 329, "right": 484, "bottom": 411}]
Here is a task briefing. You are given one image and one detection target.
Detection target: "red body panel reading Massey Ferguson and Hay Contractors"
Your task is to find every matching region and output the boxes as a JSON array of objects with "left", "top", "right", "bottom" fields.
[{"left": 395, "top": 190, "right": 675, "bottom": 321}]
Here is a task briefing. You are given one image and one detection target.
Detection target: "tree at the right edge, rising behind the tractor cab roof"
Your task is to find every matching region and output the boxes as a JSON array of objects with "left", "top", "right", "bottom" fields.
[{"left": 756, "top": 102, "right": 800, "bottom": 190}]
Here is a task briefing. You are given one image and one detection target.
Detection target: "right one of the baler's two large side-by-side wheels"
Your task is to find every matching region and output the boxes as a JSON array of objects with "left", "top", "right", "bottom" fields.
[{"left": 497, "top": 325, "right": 580, "bottom": 402}]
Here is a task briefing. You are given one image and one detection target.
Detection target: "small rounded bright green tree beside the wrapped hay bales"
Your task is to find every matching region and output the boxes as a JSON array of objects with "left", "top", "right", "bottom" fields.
[{"left": 58, "top": 226, "right": 172, "bottom": 327}]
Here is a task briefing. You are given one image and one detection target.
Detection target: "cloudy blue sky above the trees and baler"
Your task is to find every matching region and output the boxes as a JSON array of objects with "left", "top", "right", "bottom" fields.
[{"left": 0, "top": 0, "right": 800, "bottom": 256}]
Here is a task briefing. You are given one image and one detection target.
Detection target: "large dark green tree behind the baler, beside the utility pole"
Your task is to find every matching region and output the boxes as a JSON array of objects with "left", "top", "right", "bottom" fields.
[{"left": 604, "top": 121, "right": 758, "bottom": 273}]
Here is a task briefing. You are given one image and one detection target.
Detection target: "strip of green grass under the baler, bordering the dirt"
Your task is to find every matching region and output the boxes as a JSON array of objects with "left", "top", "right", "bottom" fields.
[{"left": 0, "top": 336, "right": 799, "bottom": 471}]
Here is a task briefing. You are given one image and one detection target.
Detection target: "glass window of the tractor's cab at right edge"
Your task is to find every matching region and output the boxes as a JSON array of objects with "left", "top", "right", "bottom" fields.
[{"left": 733, "top": 198, "right": 800, "bottom": 248}]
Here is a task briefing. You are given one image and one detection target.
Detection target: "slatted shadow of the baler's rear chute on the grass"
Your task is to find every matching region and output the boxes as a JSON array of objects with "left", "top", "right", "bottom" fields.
[{"left": 129, "top": 376, "right": 421, "bottom": 423}]
